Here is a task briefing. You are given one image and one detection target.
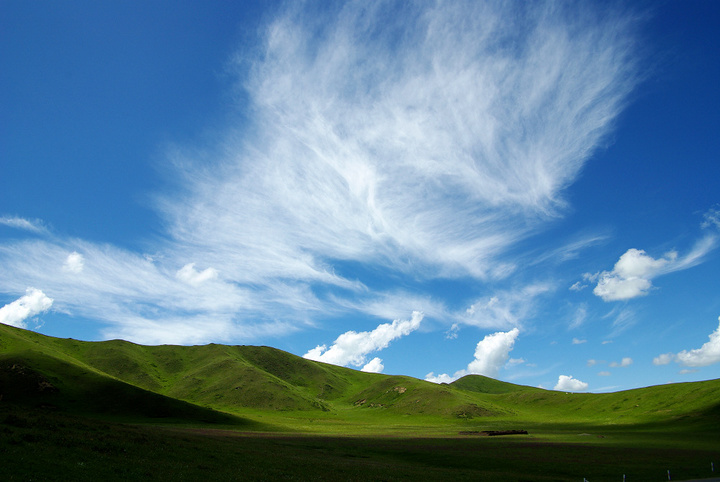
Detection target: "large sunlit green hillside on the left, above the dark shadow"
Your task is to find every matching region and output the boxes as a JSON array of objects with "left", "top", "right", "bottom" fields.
[{"left": 0, "top": 326, "right": 508, "bottom": 417}]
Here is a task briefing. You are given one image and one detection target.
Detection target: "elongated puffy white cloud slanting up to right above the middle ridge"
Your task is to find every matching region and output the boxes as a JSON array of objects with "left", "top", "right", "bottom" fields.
[{"left": 303, "top": 311, "right": 424, "bottom": 367}]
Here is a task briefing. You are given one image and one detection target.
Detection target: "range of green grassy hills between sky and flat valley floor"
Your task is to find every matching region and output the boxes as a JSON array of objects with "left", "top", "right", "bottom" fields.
[{"left": 0, "top": 325, "right": 720, "bottom": 429}]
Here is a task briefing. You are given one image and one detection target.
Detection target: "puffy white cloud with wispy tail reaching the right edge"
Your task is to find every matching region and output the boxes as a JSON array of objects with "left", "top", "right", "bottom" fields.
[{"left": 584, "top": 236, "right": 716, "bottom": 301}]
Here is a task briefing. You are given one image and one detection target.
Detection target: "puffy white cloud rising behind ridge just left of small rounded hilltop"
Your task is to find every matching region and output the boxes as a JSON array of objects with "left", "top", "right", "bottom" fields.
[{"left": 425, "top": 328, "right": 520, "bottom": 383}]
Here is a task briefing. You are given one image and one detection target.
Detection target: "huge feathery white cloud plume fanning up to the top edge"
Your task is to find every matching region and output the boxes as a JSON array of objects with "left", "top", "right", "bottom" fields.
[{"left": 163, "top": 2, "right": 633, "bottom": 294}]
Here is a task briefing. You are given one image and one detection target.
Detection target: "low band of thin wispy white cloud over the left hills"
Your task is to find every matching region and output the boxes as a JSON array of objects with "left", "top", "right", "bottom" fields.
[{"left": 0, "top": 241, "right": 258, "bottom": 344}]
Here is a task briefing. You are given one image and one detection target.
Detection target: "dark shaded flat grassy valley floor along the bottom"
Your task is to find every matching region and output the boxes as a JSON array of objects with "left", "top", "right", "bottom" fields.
[{"left": 0, "top": 405, "right": 720, "bottom": 482}]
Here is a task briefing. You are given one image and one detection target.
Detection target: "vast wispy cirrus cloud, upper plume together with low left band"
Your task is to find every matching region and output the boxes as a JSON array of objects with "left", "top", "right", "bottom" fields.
[{"left": 0, "top": 1, "right": 638, "bottom": 343}]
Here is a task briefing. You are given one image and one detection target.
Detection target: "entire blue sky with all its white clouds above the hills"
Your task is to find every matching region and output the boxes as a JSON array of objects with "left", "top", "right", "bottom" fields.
[{"left": 0, "top": 1, "right": 720, "bottom": 391}]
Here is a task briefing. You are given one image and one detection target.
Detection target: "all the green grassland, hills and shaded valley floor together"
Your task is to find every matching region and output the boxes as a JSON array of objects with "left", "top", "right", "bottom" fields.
[{"left": 0, "top": 325, "right": 720, "bottom": 482}]
